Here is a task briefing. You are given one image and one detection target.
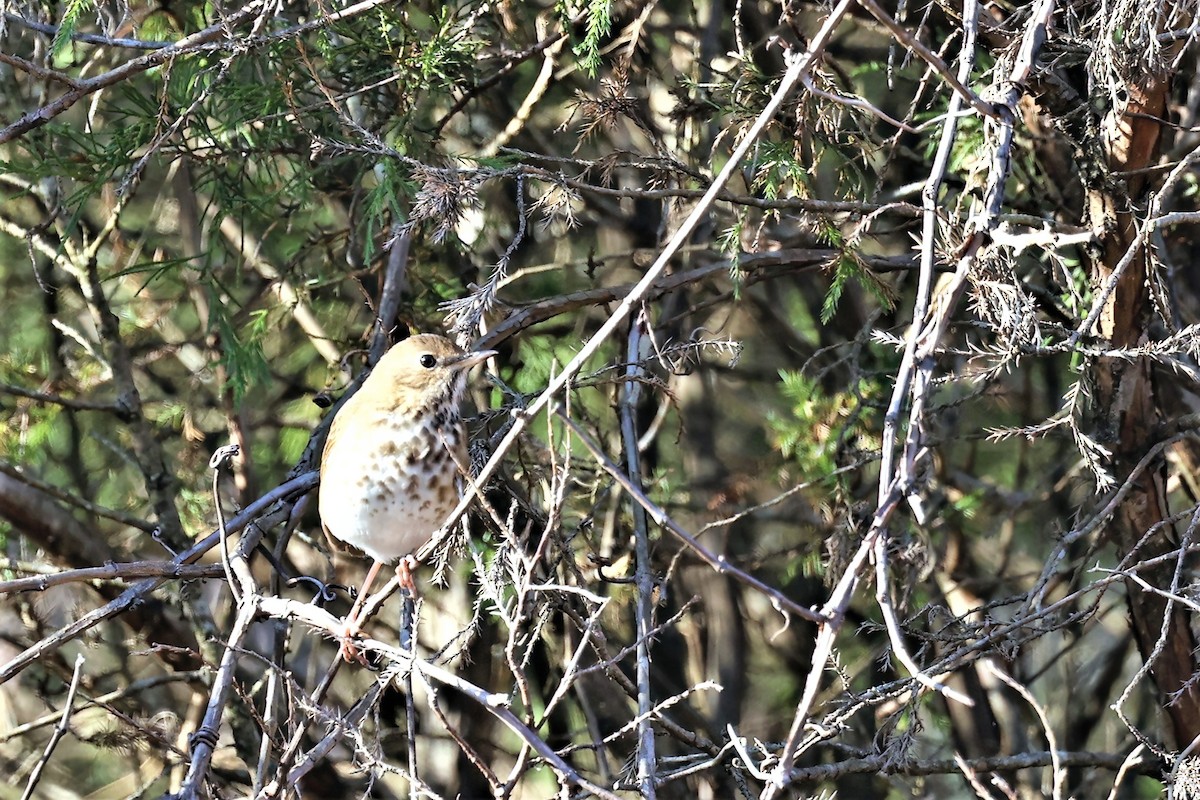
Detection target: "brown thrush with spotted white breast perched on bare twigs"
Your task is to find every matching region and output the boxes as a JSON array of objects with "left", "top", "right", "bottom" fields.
[{"left": 317, "top": 333, "right": 496, "bottom": 661}]
